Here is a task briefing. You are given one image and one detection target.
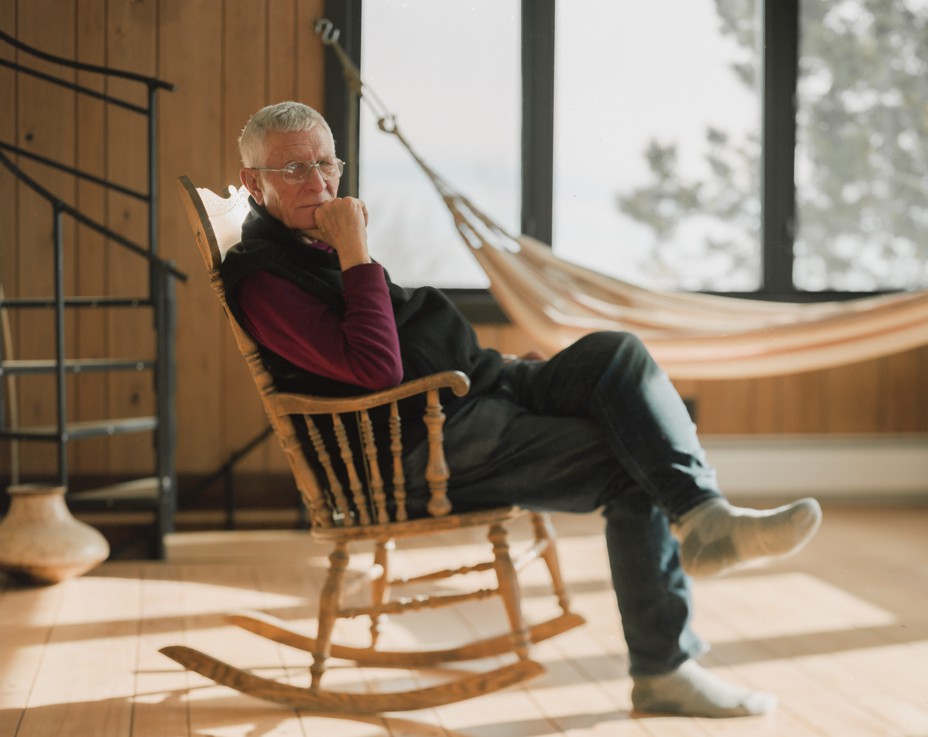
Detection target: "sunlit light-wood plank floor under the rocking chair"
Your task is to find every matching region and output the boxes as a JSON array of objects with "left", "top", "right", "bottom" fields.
[{"left": 0, "top": 507, "right": 928, "bottom": 737}]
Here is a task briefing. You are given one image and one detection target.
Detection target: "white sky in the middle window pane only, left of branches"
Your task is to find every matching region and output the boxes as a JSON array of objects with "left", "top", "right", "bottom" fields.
[{"left": 554, "top": 0, "right": 759, "bottom": 287}]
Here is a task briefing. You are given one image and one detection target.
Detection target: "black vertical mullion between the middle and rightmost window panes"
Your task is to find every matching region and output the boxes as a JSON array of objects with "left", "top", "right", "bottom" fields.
[{"left": 761, "top": 0, "right": 799, "bottom": 296}]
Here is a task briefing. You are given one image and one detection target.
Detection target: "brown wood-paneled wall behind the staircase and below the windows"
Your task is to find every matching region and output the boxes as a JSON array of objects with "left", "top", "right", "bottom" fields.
[{"left": 0, "top": 0, "right": 928, "bottom": 484}]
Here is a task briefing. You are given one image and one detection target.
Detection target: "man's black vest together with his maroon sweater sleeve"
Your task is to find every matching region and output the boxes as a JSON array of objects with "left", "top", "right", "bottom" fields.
[{"left": 220, "top": 201, "right": 503, "bottom": 406}]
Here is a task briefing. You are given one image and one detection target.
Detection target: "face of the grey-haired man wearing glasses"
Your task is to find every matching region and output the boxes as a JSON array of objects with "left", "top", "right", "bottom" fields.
[{"left": 241, "top": 125, "right": 339, "bottom": 230}]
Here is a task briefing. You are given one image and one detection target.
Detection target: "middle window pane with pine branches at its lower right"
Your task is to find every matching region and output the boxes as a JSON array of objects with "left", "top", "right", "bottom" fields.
[{"left": 553, "top": 0, "right": 761, "bottom": 291}]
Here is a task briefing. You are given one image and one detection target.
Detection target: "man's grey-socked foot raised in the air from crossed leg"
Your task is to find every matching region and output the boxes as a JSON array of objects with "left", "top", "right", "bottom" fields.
[{"left": 679, "top": 499, "right": 822, "bottom": 577}]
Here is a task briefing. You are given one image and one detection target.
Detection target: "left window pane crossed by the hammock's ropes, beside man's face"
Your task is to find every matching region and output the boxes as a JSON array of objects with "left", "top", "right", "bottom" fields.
[{"left": 359, "top": 0, "right": 522, "bottom": 287}]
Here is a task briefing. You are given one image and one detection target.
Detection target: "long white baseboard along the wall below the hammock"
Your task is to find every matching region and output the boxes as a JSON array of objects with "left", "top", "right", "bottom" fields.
[{"left": 701, "top": 435, "right": 928, "bottom": 503}]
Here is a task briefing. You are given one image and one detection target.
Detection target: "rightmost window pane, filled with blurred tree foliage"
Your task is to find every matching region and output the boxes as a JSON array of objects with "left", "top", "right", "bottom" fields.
[{"left": 793, "top": 0, "right": 928, "bottom": 291}]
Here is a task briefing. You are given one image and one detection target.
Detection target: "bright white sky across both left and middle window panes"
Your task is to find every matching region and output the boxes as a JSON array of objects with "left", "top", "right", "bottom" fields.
[{"left": 361, "top": 0, "right": 758, "bottom": 286}]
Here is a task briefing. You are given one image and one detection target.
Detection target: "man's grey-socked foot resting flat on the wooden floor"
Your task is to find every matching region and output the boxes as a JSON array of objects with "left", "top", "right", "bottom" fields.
[{"left": 632, "top": 660, "right": 777, "bottom": 718}]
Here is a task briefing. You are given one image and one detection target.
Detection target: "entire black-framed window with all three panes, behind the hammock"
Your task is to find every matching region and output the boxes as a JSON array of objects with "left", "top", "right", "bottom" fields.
[{"left": 330, "top": 0, "right": 928, "bottom": 299}]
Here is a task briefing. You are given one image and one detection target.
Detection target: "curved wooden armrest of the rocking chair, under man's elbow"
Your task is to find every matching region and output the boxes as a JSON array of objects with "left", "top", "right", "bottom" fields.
[{"left": 266, "top": 371, "right": 470, "bottom": 416}]
